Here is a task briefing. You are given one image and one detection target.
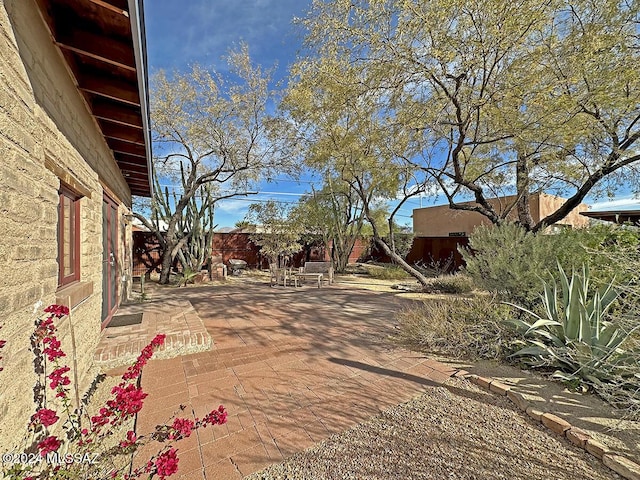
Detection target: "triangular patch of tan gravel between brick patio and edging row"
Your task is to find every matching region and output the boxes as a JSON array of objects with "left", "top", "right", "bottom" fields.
[{"left": 246, "top": 379, "right": 621, "bottom": 480}]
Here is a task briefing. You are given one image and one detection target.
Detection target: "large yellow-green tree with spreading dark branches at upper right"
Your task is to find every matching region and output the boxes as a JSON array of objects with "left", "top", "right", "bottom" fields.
[{"left": 297, "top": 0, "right": 640, "bottom": 231}]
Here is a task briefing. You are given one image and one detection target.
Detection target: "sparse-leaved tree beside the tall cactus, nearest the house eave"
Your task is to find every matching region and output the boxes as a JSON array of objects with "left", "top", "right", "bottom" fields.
[{"left": 137, "top": 45, "right": 291, "bottom": 283}]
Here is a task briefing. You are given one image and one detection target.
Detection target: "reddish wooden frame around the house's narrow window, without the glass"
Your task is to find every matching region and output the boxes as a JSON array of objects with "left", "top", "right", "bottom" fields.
[{"left": 57, "top": 185, "right": 82, "bottom": 287}]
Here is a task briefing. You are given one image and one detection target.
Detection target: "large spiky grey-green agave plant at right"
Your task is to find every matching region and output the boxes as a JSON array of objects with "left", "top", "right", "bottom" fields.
[{"left": 510, "top": 264, "right": 638, "bottom": 384}]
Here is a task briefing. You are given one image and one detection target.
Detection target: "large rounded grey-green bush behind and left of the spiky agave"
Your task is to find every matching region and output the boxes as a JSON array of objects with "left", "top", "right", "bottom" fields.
[{"left": 460, "top": 224, "right": 588, "bottom": 307}]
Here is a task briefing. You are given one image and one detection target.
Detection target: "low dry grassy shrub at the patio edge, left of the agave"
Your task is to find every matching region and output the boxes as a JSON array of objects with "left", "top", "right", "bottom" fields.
[{"left": 396, "top": 295, "right": 515, "bottom": 360}]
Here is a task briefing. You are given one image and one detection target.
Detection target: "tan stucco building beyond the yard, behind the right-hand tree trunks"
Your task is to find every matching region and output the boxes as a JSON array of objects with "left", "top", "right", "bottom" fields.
[{"left": 413, "top": 194, "right": 589, "bottom": 237}]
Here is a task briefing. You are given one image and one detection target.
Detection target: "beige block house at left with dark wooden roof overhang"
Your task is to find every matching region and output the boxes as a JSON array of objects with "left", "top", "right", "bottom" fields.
[{"left": 0, "top": 0, "right": 151, "bottom": 452}]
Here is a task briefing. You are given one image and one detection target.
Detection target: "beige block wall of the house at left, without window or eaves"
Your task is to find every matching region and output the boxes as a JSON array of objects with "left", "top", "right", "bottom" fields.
[{"left": 0, "top": 0, "right": 131, "bottom": 451}]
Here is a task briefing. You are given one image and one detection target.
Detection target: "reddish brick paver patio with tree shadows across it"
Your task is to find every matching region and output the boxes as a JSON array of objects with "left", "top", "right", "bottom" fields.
[{"left": 136, "top": 283, "right": 453, "bottom": 480}]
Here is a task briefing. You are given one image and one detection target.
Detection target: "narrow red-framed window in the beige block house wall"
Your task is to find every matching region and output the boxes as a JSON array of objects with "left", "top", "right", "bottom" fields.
[{"left": 58, "top": 187, "right": 80, "bottom": 286}]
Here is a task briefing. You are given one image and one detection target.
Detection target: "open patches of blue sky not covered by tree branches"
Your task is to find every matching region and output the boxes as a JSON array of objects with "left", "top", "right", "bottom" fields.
[{"left": 144, "top": 0, "right": 631, "bottom": 228}]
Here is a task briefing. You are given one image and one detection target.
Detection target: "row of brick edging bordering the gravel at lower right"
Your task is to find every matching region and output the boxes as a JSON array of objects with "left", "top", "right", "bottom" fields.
[{"left": 454, "top": 370, "right": 640, "bottom": 480}]
